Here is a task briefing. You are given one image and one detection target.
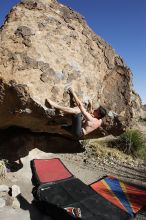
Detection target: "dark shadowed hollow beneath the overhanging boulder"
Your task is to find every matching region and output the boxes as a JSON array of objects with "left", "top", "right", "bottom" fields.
[{"left": 0, "top": 127, "right": 84, "bottom": 161}]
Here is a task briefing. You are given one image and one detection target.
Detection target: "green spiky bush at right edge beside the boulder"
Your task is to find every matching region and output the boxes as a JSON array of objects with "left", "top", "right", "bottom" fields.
[{"left": 119, "top": 130, "right": 146, "bottom": 159}]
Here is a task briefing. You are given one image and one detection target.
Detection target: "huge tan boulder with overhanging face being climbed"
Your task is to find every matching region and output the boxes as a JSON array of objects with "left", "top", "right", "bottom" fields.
[{"left": 0, "top": 0, "right": 141, "bottom": 137}]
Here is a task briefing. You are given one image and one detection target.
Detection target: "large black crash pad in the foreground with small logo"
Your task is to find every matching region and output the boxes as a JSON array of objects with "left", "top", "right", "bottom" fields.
[{"left": 34, "top": 178, "right": 131, "bottom": 220}]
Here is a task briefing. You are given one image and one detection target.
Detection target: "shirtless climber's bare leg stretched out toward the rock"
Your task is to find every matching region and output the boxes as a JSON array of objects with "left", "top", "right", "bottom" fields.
[{"left": 46, "top": 99, "right": 80, "bottom": 114}]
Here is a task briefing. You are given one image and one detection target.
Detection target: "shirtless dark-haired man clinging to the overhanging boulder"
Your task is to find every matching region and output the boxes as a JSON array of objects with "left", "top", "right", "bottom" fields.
[{"left": 46, "top": 88, "right": 107, "bottom": 139}]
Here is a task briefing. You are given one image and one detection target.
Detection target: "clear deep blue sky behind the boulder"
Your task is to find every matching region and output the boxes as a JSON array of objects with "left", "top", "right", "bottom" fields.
[{"left": 0, "top": 0, "right": 146, "bottom": 104}]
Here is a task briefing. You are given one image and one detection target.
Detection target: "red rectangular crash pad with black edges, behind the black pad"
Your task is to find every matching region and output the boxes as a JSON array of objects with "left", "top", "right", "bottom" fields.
[{"left": 31, "top": 158, "right": 73, "bottom": 185}]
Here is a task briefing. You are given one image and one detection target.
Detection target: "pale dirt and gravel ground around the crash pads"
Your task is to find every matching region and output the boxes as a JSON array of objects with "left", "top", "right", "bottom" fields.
[{"left": 0, "top": 123, "right": 146, "bottom": 220}]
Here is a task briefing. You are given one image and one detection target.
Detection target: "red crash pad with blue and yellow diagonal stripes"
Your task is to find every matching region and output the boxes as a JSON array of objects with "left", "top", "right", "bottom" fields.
[{"left": 90, "top": 176, "right": 146, "bottom": 216}]
